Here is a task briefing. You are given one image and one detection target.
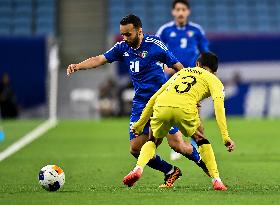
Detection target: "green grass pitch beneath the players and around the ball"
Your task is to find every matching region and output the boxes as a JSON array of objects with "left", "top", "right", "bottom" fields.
[{"left": 0, "top": 118, "right": 280, "bottom": 205}]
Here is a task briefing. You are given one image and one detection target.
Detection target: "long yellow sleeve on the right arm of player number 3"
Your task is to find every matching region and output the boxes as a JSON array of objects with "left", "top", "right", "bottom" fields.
[{"left": 209, "top": 79, "right": 230, "bottom": 144}]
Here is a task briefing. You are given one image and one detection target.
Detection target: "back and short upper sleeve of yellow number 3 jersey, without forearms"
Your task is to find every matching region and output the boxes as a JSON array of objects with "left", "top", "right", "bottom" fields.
[{"left": 155, "top": 67, "right": 224, "bottom": 109}]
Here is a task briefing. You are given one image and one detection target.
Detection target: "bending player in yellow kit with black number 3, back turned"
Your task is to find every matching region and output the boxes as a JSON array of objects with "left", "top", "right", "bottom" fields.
[{"left": 123, "top": 52, "right": 235, "bottom": 190}]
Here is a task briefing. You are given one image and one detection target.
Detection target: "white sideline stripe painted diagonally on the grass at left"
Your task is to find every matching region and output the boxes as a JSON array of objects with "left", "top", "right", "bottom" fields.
[{"left": 0, "top": 119, "right": 57, "bottom": 162}]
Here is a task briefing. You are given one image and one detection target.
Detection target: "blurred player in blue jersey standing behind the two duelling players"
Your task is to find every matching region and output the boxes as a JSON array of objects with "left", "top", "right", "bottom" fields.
[{"left": 156, "top": 0, "right": 209, "bottom": 160}]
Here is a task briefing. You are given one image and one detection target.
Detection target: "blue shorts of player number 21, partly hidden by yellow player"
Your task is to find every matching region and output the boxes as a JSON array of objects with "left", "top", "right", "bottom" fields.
[{"left": 129, "top": 105, "right": 179, "bottom": 140}]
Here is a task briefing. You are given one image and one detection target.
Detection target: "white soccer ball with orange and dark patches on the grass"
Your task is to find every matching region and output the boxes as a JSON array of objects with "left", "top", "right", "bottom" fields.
[{"left": 39, "top": 165, "right": 65, "bottom": 191}]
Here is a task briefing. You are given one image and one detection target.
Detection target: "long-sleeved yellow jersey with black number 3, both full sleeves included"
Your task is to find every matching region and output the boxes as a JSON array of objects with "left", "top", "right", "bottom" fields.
[{"left": 133, "top": 67, "right": 230, "bottom": 143}]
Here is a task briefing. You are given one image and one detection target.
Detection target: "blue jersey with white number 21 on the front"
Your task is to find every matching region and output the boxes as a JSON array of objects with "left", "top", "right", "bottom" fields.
[{"left": 104, "top": 34, "right": 178, "bottom": 105}]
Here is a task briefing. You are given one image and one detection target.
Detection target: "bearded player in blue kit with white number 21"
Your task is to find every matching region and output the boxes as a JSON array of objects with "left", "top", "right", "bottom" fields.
[{"left": 67, "top": 15, "right": 205, "bottom": 187}]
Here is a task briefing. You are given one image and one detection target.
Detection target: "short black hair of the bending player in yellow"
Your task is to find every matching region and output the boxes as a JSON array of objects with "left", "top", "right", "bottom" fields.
[{"left": 196, "top": 52, "right": 219, "bottom": 72}]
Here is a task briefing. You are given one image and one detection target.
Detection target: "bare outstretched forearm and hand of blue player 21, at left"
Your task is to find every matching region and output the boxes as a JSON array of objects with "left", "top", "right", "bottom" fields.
[{"left": 67, "top": 55, "right": 108, "bottom": 76}]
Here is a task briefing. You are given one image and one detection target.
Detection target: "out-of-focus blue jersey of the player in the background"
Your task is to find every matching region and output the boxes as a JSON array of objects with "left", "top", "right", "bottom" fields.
[{"left": 156, "top": 21, "right": 209, "bottom": 68}]
